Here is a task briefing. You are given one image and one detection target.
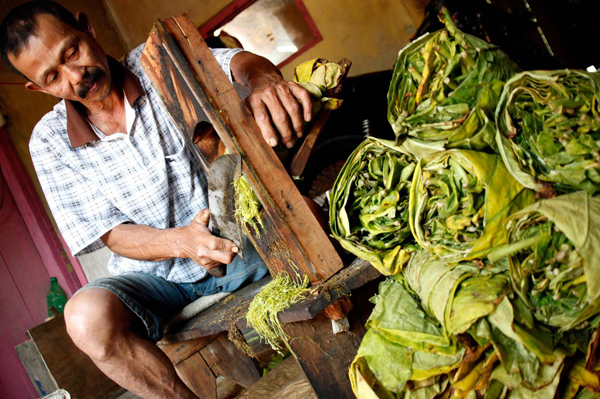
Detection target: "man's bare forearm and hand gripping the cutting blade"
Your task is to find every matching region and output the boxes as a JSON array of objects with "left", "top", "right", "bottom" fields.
[{"left": 101, "top": 209, "right": 238, "bottom": 269}]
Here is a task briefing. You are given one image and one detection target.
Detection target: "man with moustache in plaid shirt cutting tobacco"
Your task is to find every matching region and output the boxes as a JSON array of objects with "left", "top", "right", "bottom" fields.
[{"left": 0, "top": 1, "right": 312, "bottom": 398}]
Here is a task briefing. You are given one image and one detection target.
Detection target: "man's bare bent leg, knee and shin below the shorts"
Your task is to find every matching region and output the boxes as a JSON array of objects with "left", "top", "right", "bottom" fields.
[{"left": 65, "top": 288, "right": 198, "bottom": 399}]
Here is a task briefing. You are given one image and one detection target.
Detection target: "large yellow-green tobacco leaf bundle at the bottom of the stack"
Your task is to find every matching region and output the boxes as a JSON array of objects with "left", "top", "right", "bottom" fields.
[{"left": 350, "top": 251, "right": 580, "bottom": 399}]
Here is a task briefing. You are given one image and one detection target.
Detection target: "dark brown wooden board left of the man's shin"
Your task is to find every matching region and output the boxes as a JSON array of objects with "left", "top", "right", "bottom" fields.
[{"left": 29, "top": 315, "right": 120, "bottom": 399}]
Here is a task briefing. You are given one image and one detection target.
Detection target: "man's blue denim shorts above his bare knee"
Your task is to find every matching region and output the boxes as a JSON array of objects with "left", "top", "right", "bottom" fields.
[{"left": 78, "top": 238, "right": 269, "bottom": 342}]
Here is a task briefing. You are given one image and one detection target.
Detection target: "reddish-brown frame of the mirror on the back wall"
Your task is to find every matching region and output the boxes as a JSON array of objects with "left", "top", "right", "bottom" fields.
[{"left": 198, "top": 0, "right": 323, "bottom": 68}]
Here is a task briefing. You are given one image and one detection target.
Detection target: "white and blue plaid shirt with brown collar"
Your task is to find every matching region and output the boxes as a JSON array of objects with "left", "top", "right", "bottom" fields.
[{"left": 29, "top": 44, "right": 241, "bottom": 283}]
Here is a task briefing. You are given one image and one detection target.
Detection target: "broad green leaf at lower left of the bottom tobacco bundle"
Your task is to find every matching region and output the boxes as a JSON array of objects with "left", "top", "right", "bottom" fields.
[{"left": 350, "top": 275, "right": 465, "bottom": 398}]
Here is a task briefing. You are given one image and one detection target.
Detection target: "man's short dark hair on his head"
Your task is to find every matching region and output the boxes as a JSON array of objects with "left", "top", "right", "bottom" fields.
[{"left": 0, "top": 0, "right": 81, "bottom": 79}]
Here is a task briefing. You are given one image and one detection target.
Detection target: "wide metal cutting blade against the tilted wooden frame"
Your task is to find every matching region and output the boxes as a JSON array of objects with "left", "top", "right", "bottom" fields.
[{"left": 208, "top": 154, "right": 244, "bottom": 259}]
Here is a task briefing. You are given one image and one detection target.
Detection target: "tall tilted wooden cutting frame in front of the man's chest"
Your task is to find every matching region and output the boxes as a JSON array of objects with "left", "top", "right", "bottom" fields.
[{"left": 141, "top": 14, "right": 343, "bottom": 283}]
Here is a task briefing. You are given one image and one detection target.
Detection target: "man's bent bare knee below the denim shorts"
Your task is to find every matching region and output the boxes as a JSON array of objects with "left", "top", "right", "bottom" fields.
[{"left": 65, "top": 288, "right": 132, "bottom": 361}]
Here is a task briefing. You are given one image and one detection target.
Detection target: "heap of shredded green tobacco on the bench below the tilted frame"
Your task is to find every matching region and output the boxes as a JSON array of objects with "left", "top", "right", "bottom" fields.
[{"left": 246, "top": 274, "right": 311, "bottom": 353}]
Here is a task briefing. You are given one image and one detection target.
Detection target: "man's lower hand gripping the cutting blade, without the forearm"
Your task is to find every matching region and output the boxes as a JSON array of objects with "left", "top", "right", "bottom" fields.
[{"left": 179, "top": 208, "right": 239, "bottom": 269}]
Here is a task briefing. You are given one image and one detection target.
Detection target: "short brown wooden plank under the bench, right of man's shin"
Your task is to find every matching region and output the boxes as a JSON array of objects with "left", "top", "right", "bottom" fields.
[{"left": 200, "top": 334, "right": 261, "bottom": 388}]
